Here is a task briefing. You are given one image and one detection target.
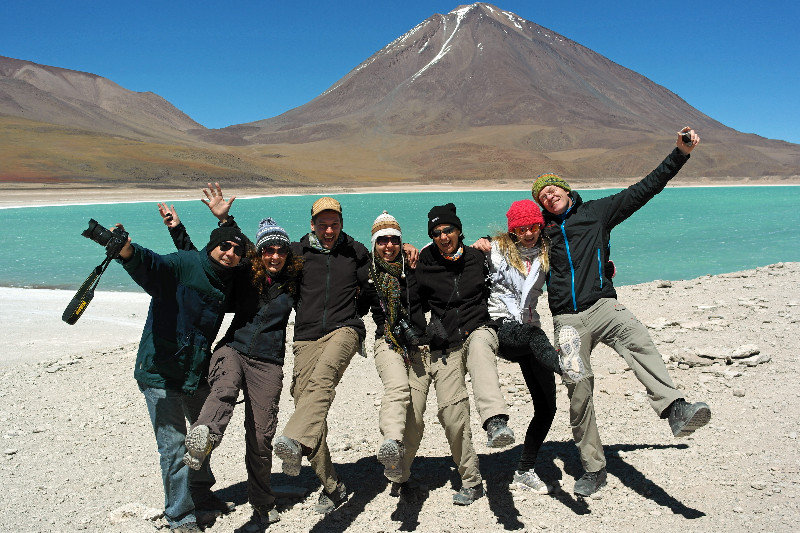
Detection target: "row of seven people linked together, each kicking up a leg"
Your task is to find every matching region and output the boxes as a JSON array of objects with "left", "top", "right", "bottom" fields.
[{"left": 112, "top": 128, "right": 711, "bottom": 531}]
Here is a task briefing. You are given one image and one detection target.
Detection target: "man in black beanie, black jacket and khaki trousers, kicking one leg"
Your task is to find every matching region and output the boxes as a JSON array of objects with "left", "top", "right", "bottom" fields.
[{"left": 416, "top": 203, "right": 514, "bottom": 505}]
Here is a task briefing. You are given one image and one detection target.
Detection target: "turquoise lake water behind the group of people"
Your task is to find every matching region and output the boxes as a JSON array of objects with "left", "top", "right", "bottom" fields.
[{"left": 0, "top": 186, "right": 800, "bottom": 291}]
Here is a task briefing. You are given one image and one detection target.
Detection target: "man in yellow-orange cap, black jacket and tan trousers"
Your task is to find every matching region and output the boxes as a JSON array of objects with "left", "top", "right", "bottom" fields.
[{"left": 274, "top": 197, "right": 374, "bottom": 514}]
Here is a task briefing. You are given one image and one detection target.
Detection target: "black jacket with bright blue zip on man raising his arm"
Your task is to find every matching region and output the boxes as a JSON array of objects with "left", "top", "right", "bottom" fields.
[{"left": 543, "top": 148, "right": 689, "bottom": 315}]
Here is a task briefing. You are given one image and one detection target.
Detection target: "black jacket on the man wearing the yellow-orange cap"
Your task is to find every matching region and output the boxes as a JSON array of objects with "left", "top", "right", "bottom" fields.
[{"left": 292, "top": 232, "right": 375, "bottom": 341}]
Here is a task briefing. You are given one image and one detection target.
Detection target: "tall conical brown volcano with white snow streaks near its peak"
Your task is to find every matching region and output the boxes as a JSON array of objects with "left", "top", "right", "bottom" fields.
[{"left": 222, "top": 3, "right": 800, "bottom": 179}]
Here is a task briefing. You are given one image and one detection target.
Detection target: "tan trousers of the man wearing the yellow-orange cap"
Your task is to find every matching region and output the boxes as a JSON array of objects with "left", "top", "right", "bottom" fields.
[{"left": 283, "top": 327, "right": 360, "bottom": 494}]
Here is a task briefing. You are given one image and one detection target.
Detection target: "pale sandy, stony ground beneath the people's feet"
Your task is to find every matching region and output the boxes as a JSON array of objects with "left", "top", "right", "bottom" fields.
[{"left": 0, "top": 263, "right": 800, "bottom": 533}]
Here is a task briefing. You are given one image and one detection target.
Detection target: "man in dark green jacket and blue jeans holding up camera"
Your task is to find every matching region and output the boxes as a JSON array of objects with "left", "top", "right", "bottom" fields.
[{"left": 119, "top": 218, "right": 247, "bottom": 532}]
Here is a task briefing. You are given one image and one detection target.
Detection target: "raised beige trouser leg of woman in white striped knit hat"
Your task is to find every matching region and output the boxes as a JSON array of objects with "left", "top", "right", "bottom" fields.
[{"left": 375, "top": 338, "right": 411, "bottom": 442}]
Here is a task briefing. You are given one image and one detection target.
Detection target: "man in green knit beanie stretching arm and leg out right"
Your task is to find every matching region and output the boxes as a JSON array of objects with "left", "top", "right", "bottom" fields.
[{"left": 531, "top": 127, "right": 711, "bottom": 497}]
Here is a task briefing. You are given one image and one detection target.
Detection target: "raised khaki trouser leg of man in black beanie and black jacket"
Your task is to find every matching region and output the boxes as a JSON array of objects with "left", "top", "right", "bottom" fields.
[{"left": 462, "top": 326, "right": 508, "bottom": 429}]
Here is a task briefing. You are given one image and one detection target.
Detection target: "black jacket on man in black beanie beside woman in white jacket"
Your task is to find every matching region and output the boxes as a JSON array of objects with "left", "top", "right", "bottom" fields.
[{"left": 416, "top": 244, "right": 490, "bottom": 350}]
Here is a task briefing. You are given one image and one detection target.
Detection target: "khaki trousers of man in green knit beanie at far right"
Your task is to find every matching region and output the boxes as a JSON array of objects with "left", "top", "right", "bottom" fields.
[{"left": 553, "top": 298, "right": 683, "bottom": 472}]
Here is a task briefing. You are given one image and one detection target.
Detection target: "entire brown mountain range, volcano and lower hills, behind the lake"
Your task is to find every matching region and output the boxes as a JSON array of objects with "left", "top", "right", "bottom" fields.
[{"left": 0, "top": 3, "right": 800, "bottom": 187}]
